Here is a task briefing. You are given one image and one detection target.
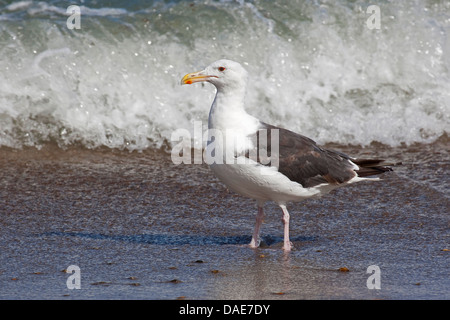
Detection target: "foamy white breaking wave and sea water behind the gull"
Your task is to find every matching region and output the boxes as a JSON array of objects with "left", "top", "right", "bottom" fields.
[{"left": 0, "top": 0, "right": 450, "bottom": 151}]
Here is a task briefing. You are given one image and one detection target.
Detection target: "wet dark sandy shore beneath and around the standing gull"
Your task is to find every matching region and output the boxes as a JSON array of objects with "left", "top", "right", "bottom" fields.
[{"left": 0, "top": 140, "right": 450, "bottom": 300}]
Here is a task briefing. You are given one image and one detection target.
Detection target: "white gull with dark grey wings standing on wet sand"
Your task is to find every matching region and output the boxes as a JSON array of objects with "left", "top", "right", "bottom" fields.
[{"left": 181, "top": 59, "right": 392, "bottom": 252}]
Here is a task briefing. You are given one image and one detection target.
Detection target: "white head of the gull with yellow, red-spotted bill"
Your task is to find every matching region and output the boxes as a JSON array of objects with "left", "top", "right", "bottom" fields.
[{"left": 181, "top": 59, "right": 247, "bottom": 91}]
